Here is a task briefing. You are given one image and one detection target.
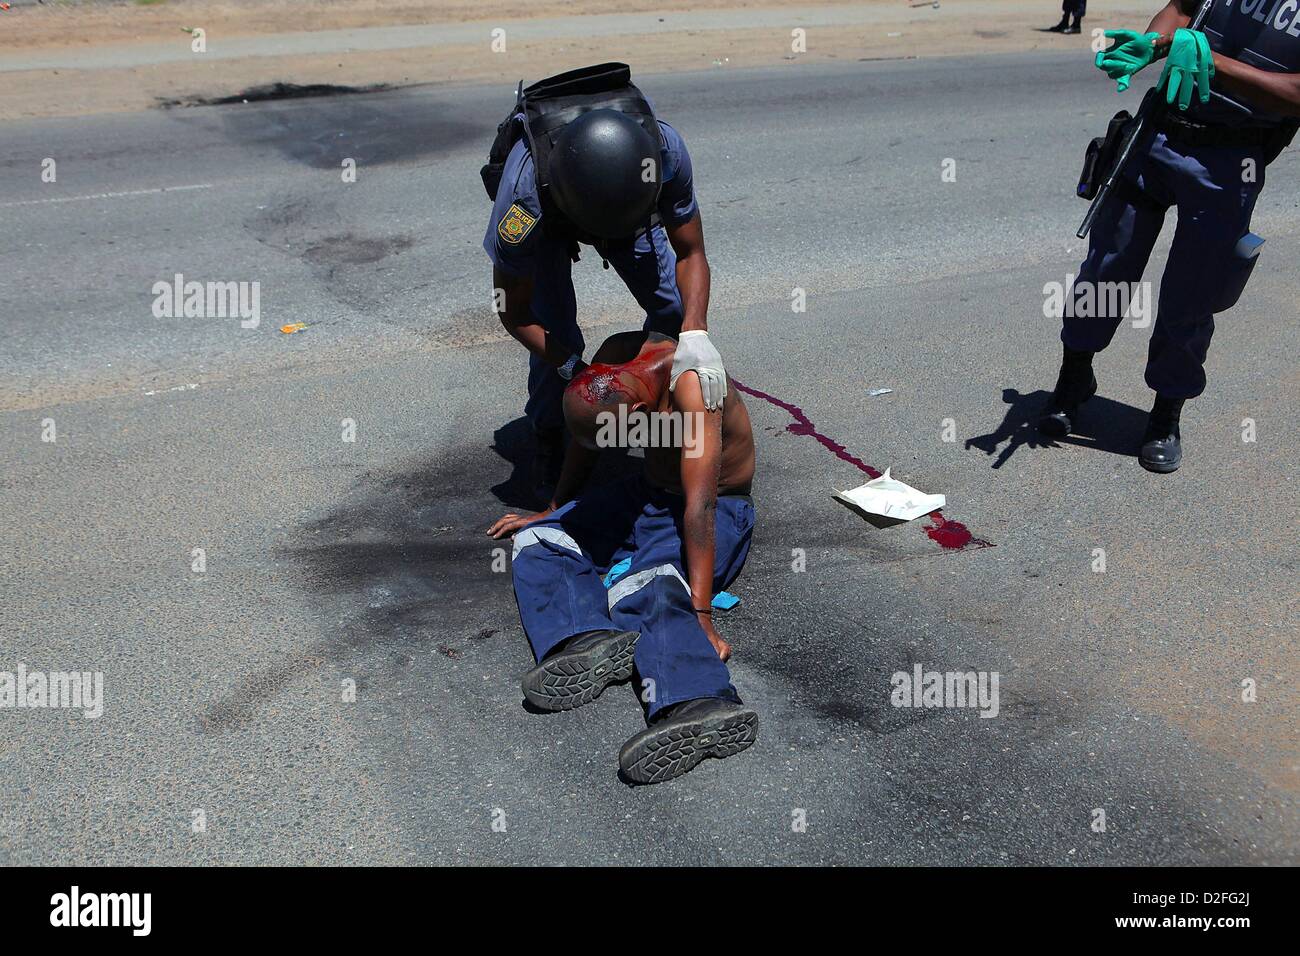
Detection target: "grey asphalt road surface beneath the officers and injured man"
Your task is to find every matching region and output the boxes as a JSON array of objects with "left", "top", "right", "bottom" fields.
[{"left": 0, "top": 53, "right": 1300, "bottom": 865}]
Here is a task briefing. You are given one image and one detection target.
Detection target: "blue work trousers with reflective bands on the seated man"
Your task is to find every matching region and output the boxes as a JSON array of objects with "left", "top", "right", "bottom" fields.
[{"left": 512, "top": 476, "right": 754, "bottom": 717}]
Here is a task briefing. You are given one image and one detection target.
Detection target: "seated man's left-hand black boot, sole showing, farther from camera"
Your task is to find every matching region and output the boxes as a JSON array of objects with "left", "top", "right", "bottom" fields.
[{"left": 520, "top": 631, "right": 641, "bottom": 710}]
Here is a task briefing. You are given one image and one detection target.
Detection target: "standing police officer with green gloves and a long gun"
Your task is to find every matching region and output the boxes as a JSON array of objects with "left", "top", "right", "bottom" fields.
[{"left": 1039, "top": 0, "right": 1300, "bottom": 472}]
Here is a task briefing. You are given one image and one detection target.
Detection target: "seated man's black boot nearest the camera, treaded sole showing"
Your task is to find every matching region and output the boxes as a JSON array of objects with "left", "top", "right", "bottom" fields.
[{"left": 619, "top": 697, "right": 758, "bottom": 783}]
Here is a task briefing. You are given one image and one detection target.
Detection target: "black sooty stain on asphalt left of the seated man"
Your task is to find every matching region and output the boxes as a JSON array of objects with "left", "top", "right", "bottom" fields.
[{"left": 200, "top": 434, "right": 527, "bottom": 732}]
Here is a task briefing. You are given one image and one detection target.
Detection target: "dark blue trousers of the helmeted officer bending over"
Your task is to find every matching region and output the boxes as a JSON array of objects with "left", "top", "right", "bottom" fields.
[{"left": 524, "top": 225, "right": 683, "bottom": 429}]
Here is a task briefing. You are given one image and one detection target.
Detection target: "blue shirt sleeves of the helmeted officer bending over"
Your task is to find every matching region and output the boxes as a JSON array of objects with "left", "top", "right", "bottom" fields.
[{"left": 484, "top": 120, "right": 696, "bottom": 276}]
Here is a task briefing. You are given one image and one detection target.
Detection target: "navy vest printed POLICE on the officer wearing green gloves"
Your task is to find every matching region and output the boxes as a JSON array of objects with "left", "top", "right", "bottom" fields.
[{"left": 1187, "top": 0, "right": 1300, "bottom": 126}]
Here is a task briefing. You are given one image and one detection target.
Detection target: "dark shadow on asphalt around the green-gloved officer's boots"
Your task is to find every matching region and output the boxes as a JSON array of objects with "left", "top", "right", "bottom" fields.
[{"left": 966, "top": 389, "right": 1147, "bottom": 468}]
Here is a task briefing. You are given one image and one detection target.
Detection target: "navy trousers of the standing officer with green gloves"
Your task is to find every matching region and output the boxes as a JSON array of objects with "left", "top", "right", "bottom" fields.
[{"left": 1061, "top": 133, "right": 1265, "bottom": 398}]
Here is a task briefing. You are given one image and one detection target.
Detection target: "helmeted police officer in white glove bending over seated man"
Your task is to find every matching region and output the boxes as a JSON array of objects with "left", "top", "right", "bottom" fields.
[{"left": 482, "top": 64, "right": 727, "bottom": 498}]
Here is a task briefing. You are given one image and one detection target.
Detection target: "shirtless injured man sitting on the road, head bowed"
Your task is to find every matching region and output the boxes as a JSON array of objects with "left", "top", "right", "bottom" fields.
[{"left": 488, "top": 332, "right": 758, "bottom": 783}]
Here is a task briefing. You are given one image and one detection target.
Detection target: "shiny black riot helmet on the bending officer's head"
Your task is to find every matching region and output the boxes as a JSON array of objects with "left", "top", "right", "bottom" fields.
[{"left": 549, "top": 109, "right": 663, "bottom": 239}]
